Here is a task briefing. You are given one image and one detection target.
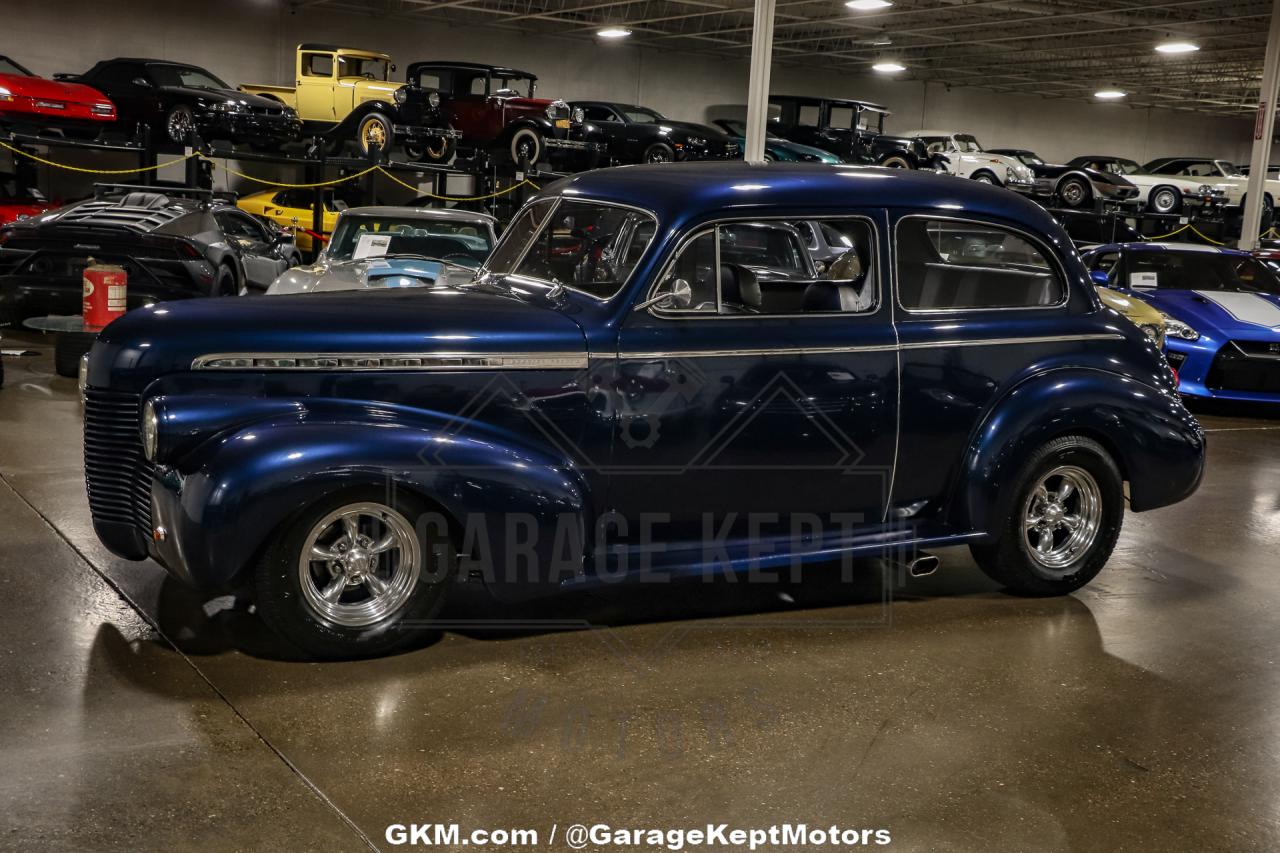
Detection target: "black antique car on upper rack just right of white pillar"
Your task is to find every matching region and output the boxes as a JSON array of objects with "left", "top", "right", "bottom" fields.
[{"left": 769, "top": 95, "right": 945, "bottom": 169}]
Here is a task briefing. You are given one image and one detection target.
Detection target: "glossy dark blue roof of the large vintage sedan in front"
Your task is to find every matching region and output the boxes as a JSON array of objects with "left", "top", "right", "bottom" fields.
[{"left": 543, "top": 160, "right": 1060, "bottom": 234}]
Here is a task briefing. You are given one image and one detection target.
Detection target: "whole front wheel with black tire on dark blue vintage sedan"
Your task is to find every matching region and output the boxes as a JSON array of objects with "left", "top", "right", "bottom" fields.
[{"left": 253, "top": 488, "right": 456, "bottom": 658}]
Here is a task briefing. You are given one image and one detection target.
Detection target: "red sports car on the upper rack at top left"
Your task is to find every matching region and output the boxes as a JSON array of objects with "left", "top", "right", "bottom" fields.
[{"left": 0, "top": 56, "right": 115, "bottom": 137}]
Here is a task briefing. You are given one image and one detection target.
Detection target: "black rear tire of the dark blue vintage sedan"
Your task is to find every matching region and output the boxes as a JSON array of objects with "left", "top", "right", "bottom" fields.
[{"left": 969, "top": 435, "right": 1124, "bottom": 596}]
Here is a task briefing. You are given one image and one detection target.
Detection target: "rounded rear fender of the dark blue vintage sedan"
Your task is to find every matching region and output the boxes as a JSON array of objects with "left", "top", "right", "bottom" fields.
[{"left": 951, "top": 368, "right": 1204, "bottom": 533}]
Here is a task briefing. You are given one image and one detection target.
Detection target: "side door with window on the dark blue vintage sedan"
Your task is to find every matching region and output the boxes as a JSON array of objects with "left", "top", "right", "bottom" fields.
[{"left": 607, "top": 211, "right": 897, "bottom": 560}]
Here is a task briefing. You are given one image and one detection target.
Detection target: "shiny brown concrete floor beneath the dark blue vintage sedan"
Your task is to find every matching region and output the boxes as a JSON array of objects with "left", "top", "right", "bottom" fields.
[{"left": 0, "top": 326, "right": 1280, "bottom": 852}]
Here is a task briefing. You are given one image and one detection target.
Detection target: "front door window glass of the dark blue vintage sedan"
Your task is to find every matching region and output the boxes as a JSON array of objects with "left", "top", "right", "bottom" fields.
[{"left": 655, "top": 218, "right": 877, "bottom": 316}]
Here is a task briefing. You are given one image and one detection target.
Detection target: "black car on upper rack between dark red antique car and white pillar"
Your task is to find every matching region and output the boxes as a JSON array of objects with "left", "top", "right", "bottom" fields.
[{"left": 570, "top": 101, "right": 742, "bottom": 164}]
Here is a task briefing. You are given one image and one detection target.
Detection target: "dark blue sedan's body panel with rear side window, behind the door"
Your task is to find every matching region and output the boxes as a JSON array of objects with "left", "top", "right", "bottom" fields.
[{"left": 892, "top": 213, "right": 1089, "bottom": 524}]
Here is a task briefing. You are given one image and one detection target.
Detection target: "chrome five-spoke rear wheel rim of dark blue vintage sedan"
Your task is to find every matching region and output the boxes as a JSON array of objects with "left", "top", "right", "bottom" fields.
[{"left": 1023, "top": 465, "right": 1102, "bottom": 571}]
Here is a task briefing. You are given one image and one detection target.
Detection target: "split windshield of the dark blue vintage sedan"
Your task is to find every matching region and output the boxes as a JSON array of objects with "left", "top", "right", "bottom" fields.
[{"left": 485, "top": 199, "right": 657, "bottom": 298}]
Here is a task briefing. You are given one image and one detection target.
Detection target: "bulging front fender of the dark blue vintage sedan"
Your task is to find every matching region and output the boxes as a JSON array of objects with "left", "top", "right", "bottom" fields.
[{"left": 152, "top": 405, "right": 588, "bottom": 598}]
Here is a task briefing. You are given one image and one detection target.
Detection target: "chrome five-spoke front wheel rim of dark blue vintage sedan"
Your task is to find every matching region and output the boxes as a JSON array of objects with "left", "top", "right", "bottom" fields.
[{"left": 298, "top": 502, "right": 422, "bottom": 628}]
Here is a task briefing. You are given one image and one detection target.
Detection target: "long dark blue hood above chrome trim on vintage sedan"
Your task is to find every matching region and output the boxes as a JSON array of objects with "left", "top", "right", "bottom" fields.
[{"left": 88, "top": 286, "right": 586, "bottom": 391}]
